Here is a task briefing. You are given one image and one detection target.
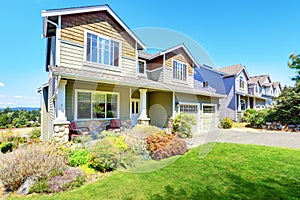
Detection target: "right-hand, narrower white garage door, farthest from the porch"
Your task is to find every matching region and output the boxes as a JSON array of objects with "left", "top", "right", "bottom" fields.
[{"left": 202, "top": 105, "right": 218, "bottom": 130}]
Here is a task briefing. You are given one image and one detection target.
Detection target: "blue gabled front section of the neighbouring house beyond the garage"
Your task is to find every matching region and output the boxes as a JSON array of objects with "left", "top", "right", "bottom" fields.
[{"left": 218, "top": 64, "right": 266, "bottom": 121}]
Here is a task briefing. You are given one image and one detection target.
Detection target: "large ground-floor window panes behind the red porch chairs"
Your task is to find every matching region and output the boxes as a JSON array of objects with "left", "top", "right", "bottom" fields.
[{"left": 76, "top": 92, "right": 119, "bottom": 119}]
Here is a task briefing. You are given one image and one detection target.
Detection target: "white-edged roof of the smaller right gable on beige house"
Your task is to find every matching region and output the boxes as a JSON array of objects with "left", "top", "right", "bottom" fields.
[{"left": 139, "top": 43, "right": 199, "bottom": 68}]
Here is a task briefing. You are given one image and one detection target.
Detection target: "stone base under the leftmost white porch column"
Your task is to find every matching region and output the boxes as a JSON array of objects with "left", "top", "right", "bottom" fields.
[{"left": 52, "top": 121, "right": 70, "bottom": 145}]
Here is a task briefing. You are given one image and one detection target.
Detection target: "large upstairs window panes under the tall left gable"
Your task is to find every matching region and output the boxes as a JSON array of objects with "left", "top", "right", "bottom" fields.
[{"left": 86, "top": 33, "right": 120, "bottom": 67}]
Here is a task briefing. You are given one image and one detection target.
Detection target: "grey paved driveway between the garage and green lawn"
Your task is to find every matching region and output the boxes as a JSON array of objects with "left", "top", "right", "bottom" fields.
[{"left": 186, "top": 128, "right": 300, "bottom": 149}]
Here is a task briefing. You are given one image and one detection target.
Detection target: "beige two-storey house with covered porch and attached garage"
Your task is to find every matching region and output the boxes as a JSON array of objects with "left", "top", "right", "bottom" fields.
[{"left": 40, "top": 5, "right": 225, "bottom": 141}]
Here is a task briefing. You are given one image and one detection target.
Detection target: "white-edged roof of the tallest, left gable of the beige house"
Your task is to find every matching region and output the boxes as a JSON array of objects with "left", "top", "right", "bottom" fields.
[{"left": 41, "top": 4, "right": 146, "bottom": 49}]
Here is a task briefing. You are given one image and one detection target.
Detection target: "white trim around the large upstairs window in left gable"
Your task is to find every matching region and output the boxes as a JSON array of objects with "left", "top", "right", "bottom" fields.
[{"left": 83, "top": 29, "right": 122, "bottom": 69}]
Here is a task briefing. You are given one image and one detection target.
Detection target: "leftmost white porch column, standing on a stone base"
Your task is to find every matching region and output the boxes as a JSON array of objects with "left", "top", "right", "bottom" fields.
[{"left": 55, "top": 80, "right": 67, "bottom": 121}]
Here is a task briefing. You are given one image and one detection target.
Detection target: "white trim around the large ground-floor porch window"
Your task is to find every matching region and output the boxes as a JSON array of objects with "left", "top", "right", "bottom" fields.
[{"left": 74, "top": 89, "right": 120, "bottom": 121}]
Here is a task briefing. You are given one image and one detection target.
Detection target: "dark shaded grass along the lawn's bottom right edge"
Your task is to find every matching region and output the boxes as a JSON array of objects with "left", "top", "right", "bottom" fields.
[{"left": 146, "top": 172, "right": 300, "bottom": 200}]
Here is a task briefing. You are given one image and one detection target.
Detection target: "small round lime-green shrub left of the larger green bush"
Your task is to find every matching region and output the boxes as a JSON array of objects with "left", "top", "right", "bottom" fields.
[{"left": 68, "top": 149, "right": 91, "bottom": 166}]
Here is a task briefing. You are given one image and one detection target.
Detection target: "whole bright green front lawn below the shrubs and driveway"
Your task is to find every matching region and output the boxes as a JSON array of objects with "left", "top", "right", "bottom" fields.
[{"left": 10, "top": 143, "right": 300, "bottom": 200}]
